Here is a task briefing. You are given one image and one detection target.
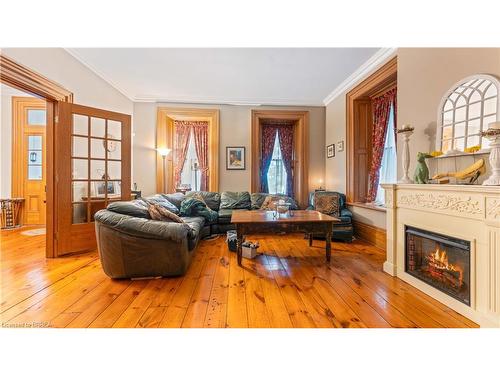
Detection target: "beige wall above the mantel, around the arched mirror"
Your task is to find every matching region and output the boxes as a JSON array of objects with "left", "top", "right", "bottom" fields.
[{"left": 398, "top": 48, "right": 500, "bottom": 181}]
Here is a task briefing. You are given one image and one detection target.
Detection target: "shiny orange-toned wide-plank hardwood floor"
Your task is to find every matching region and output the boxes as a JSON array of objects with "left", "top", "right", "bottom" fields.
[{"left": 0, "top": 230, "right": 477, "bottom": 328}]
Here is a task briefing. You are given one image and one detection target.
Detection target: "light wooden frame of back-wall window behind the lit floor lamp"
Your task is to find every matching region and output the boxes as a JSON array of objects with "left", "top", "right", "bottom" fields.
[{"left": 156, "top": 107, "right": 219, "bottom": 193}]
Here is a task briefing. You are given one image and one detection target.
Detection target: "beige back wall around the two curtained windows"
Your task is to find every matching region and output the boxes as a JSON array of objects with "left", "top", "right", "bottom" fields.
[{"left": 133, "top": 103, "right": 325, "bottom": 195}]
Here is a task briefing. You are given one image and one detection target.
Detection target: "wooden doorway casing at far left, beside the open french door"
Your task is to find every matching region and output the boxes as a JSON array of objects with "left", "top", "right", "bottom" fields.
[{"left": 0, "top": 53, "right": 73, "bottom": 258}]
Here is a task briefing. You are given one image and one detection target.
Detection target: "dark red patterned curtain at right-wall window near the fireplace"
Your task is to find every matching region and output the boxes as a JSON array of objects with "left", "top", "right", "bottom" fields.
[{"left": 367, "top": 88, "right": 396, "bottom": 202}]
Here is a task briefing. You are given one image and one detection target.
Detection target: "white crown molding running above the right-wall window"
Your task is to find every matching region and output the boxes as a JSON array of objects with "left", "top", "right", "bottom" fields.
[{"left": 323, "top": 48, "right": 398, "bottom": 107}]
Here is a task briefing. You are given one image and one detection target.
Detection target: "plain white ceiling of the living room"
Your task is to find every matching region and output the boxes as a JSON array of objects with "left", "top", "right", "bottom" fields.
[{"left": 67, "top": 48, "right": 381, "bottom": 106}]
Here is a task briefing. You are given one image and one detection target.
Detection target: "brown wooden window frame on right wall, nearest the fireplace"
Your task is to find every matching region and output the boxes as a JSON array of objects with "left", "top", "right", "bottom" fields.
[{"left": 346, "top": 56, "right": 398, "bottom": 203}]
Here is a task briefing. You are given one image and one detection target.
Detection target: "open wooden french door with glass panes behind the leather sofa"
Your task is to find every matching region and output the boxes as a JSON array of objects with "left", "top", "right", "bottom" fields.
[{"left": 54, "top": 102, "right": 131, "bottom": 256}]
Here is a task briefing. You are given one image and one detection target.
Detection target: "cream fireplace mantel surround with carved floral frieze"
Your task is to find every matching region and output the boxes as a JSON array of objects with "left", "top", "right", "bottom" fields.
[{"left": 382, "top": 184, "right": 500, "bottom": 327}]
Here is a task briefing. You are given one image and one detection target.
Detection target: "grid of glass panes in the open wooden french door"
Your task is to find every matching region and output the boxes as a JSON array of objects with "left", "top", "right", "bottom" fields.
[{"left": 71, "top": 114, "right": 122, "bottom": 224}]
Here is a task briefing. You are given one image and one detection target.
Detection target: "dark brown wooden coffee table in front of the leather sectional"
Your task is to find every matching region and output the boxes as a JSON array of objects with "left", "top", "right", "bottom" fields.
[{"left": 231, "top": 210, "right": 340, "bottom": 266}]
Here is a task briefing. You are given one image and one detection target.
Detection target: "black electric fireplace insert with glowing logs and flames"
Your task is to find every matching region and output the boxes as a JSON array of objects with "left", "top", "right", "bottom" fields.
[{"left": 405, "top": 226, "right": 470, "bottom": 306}]
